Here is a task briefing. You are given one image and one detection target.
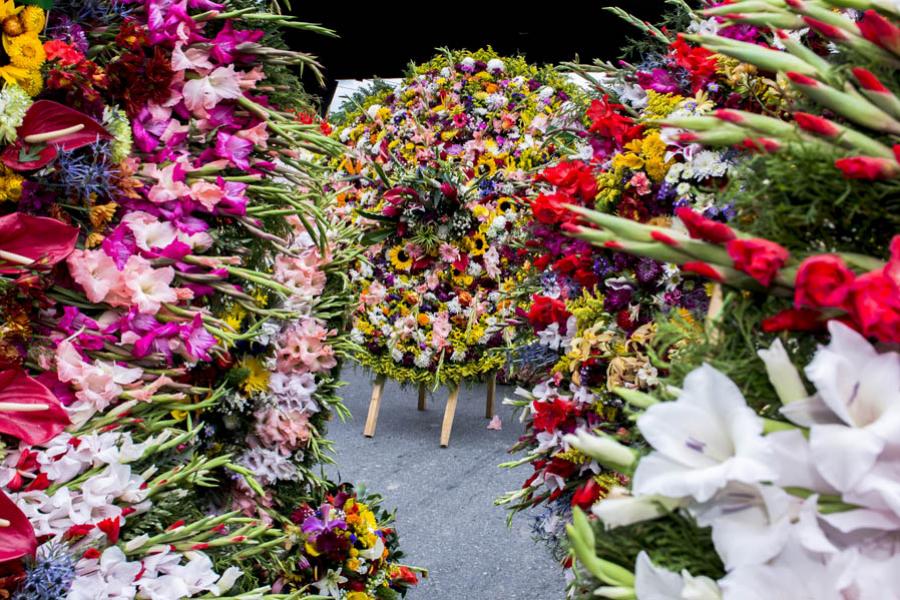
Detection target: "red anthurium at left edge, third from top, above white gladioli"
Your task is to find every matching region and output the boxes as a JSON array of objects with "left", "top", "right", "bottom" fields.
[{"left": 0, "top": 369, "right": 69, "bottom": 444}]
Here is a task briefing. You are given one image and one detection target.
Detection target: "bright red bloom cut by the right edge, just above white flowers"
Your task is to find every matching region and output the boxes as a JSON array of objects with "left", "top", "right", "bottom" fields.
[{"left": 848, "top": 269, "right": 900, "bottom": 342}]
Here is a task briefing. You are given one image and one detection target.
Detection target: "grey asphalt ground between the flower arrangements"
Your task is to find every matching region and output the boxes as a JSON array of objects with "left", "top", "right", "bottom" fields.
[{"left": 329, "top": 364, "right": 565, "bottom": 600}]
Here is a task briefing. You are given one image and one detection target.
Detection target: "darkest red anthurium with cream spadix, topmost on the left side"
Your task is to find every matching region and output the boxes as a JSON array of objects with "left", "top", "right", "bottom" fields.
[{"left": 0, "top": 100, "right": 112, "bottom": 171}]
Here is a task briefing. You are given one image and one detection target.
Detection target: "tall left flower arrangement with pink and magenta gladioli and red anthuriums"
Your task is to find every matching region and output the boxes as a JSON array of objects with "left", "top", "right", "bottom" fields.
[{"left": 0, "top": 0, "right": 415, "bottom": 600}]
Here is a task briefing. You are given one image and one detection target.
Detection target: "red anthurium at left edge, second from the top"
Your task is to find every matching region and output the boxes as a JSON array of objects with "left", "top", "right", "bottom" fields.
[{"left": 0, "top": 213, "right": 78, "bottom": 273}]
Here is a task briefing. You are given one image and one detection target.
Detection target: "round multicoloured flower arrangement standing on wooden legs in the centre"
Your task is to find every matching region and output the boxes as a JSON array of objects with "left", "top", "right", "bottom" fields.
[{"left": 335, "top": 50, "right": 569, "bottom": 382}]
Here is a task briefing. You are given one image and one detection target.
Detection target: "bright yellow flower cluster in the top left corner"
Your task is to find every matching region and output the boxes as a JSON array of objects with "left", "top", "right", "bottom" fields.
[{"left": 0, "top": 0, "right": 47, "bottom": 96}]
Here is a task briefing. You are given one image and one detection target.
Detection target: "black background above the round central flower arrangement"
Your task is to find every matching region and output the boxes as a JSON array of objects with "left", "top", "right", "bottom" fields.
[{"left": 288, "top": 0, "right": 666, "bottom": 109}]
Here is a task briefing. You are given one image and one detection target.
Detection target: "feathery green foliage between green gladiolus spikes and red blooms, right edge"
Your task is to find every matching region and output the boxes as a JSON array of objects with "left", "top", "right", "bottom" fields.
[{"left": 723, "top": 141, "right": 900, "bottom": 257}]
